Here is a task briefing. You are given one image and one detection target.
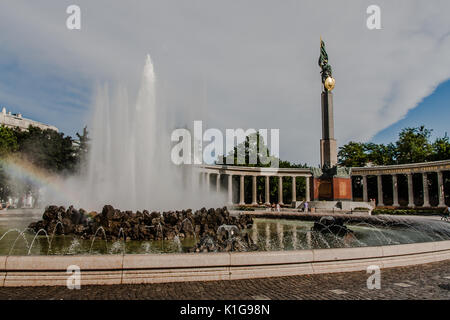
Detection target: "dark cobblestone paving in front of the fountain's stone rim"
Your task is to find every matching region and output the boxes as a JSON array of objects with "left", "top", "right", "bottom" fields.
[{"left": 0, "top": 260, "right": 450, "bottom": 300}]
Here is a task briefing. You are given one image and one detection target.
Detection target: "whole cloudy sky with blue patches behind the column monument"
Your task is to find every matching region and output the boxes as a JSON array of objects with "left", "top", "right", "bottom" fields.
[{"left": 0, "top": 0, "right": 450, "bottom": 165}]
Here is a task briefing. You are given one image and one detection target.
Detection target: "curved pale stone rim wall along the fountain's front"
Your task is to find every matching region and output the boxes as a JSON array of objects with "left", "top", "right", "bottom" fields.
[{"left": 0, "top": 241, "right": 450, "bottom": 287}]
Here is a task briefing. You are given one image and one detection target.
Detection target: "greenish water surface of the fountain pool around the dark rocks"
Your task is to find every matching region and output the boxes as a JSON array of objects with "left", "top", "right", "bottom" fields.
[{"left": 0, "top": 210, "right": 450, "bottom": 255}]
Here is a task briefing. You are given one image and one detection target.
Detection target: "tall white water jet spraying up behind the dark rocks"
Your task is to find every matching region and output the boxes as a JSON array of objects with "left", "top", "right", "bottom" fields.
[{"left": 57, "top": 55, "right": 224, "bottom": 210}]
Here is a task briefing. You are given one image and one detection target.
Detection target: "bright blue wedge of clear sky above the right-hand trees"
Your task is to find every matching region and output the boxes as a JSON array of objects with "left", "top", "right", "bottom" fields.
[{"left": 372, "top": 80, "right": 450, "bottom": 143}]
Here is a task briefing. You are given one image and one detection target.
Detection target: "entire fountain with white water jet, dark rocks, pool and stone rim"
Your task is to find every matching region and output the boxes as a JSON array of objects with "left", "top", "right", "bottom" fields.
[{"left": 0, "top": 56, "right": 450, "bottom": 284}]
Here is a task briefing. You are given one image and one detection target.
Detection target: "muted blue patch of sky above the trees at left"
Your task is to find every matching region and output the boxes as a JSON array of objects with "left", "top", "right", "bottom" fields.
[{"left": 0, "top": 54, "right": 92, "bottom": 136}]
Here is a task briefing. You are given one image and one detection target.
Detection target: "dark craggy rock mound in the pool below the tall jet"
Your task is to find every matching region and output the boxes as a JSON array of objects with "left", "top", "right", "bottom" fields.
[{"left": 29, "top": 205, "right": 254, "bottom": 252}]
